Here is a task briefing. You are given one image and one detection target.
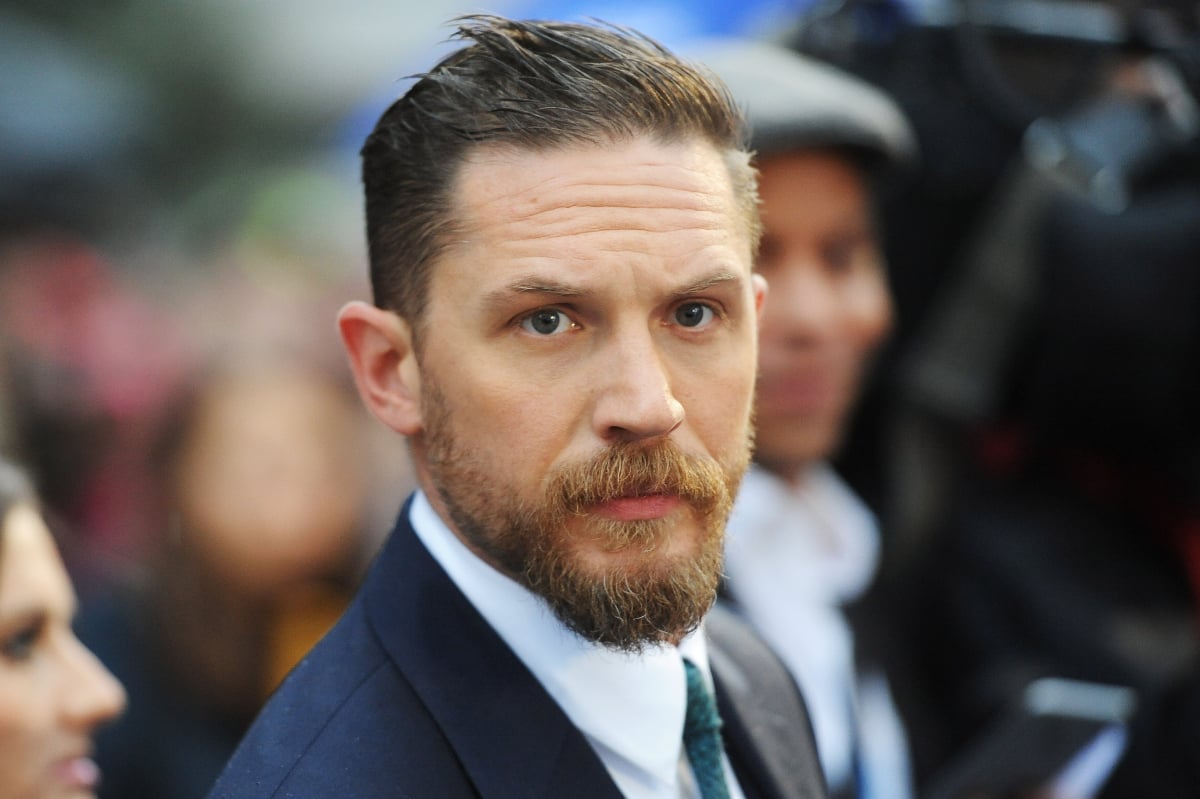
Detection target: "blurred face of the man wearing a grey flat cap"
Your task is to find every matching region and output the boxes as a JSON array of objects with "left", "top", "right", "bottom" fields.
[{"left": 755, "top": 151, "right": 892, "bottom": 477}]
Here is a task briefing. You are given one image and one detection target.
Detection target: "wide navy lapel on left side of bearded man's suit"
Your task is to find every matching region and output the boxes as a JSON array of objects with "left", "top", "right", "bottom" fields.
[{"left": 364, "top": 505, "right": 620, "bottom": 799}]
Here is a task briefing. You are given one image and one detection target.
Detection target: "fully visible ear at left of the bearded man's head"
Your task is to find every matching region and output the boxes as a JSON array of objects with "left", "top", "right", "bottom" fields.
[{"left": 337, "top": 301, "right": 421, "bottom": 435}]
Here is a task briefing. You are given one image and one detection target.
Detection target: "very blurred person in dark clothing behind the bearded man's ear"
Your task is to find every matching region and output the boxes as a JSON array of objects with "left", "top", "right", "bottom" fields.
[{"left": 73, "top": 353, "right": 388, "bottom": 799}]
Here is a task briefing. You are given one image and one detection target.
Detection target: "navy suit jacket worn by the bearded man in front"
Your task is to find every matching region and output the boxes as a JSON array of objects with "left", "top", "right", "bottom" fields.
[{"left": 209, "top": 504, "right": 824, "bottom": 799}]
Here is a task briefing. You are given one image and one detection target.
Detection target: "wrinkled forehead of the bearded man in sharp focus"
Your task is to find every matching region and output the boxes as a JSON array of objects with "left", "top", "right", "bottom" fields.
[{"left": 450, "top": 138, "right": 750, "bottom": 272}]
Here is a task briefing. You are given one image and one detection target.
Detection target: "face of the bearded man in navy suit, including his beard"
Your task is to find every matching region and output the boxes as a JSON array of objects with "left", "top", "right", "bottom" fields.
[{"left": 413, "top": 139, "right": 763, "bottom": 650}]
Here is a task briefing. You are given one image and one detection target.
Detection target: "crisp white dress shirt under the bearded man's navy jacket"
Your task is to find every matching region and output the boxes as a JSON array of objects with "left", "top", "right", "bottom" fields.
[{"left": 410, "top": 492, "right": 744, "bottom": 799}]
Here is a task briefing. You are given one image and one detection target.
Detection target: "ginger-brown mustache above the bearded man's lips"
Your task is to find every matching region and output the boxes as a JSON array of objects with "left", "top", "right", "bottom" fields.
[{"left": 548, "top": 441, "right": 726, "bottom": 515}]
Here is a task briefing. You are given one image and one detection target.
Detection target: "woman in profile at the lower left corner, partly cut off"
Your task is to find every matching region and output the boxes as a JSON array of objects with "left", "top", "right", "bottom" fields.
[{"left": 0, "top": 458, "right": 125, "bottom": 799}]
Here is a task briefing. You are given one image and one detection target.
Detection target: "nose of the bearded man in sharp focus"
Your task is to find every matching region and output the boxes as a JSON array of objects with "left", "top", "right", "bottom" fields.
[{"left": 593, "top": 329, "right": 684, "bottom": 443}]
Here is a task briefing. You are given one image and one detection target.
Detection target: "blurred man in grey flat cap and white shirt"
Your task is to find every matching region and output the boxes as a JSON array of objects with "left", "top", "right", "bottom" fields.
[{"left": 697, "top": 41, "right": 914, "bottom": 799}]
